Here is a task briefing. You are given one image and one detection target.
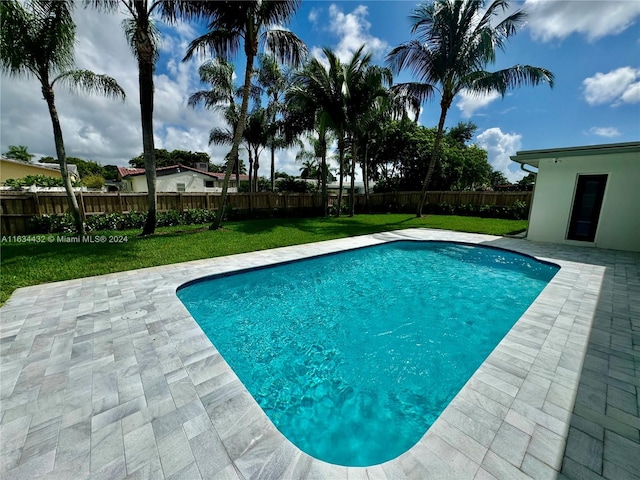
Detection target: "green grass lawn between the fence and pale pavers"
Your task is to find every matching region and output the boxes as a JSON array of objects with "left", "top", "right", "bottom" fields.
[{"left": 0, "top": 214, "right": 527, "bottom": 304}]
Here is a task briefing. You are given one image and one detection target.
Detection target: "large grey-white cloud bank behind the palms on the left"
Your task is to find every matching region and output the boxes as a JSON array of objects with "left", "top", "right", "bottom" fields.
[{"left": 0, "top": 8, "right": 235, "bottom": 169}]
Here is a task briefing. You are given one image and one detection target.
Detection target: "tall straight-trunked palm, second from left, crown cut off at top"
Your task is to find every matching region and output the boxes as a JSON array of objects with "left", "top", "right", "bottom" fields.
[{"left": 84, "top": 0, "right": 201, "bottom": 235}]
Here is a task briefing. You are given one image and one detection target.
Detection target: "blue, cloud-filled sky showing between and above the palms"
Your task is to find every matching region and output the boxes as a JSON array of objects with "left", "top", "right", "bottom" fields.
[{"left": 0, "top": 0, "right": 640, "bottom": 182}]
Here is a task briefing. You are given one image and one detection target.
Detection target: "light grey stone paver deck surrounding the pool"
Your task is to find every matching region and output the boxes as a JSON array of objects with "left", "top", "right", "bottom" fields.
[{"left": 0, "top": 229, "right": 640, "bottom": 480}]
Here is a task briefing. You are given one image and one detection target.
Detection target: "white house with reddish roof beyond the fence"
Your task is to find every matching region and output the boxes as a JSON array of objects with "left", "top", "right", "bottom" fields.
[{"left": 118, "top": 164, "right": 249, "bottom": 193}]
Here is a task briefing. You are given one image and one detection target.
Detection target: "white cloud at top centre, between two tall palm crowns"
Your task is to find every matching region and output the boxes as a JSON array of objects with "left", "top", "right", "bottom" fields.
[{"left": 309, "top": 4, "right": 390, "bottom": 61}]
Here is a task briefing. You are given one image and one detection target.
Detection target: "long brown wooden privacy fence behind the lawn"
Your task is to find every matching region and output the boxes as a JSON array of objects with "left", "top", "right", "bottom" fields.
[{"left": 0, "top": 191, "right": 531, "bottom": 235}]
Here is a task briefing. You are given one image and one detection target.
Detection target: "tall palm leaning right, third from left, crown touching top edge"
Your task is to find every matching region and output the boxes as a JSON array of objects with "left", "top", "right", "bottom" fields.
[{"left": 183, "top": 0, "right": 306, "bottom": 230}]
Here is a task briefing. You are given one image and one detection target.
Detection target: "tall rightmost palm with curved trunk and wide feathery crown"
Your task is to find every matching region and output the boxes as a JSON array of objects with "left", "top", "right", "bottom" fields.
[{"left": 387, "top": 0, "right": 553, "bottom": 216}]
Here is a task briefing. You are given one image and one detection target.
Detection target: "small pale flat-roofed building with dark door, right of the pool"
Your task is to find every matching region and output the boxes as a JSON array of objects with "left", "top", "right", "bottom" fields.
[{"left": 511, "top": 142, "right": 640, "bottom": 252}]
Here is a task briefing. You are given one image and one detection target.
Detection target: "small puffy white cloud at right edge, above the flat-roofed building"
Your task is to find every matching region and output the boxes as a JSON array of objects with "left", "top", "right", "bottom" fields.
[{"left": 582, "top": 67, "right": 640, "bottom": 106}]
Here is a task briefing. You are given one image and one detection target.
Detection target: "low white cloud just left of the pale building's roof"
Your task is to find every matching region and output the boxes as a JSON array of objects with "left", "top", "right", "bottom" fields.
[{"left": 476, "top": 127, "right": 525, "bottom": 182}]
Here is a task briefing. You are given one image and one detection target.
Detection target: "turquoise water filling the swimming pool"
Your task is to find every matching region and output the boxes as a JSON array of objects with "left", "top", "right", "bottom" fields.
[{"left": 178, "top": 241, "right": 558, "bottom": 466}]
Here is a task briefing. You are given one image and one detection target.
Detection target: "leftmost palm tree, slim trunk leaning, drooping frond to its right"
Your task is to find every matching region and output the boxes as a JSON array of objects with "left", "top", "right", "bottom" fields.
[{"left": 0, "top": 0, "right": 125, "bottom": 234}]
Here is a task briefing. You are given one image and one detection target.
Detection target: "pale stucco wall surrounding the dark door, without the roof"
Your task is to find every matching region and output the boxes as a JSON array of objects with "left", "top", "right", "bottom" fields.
[{"left": 527, "top": 152, "right": 640, "bottom": 251}]
